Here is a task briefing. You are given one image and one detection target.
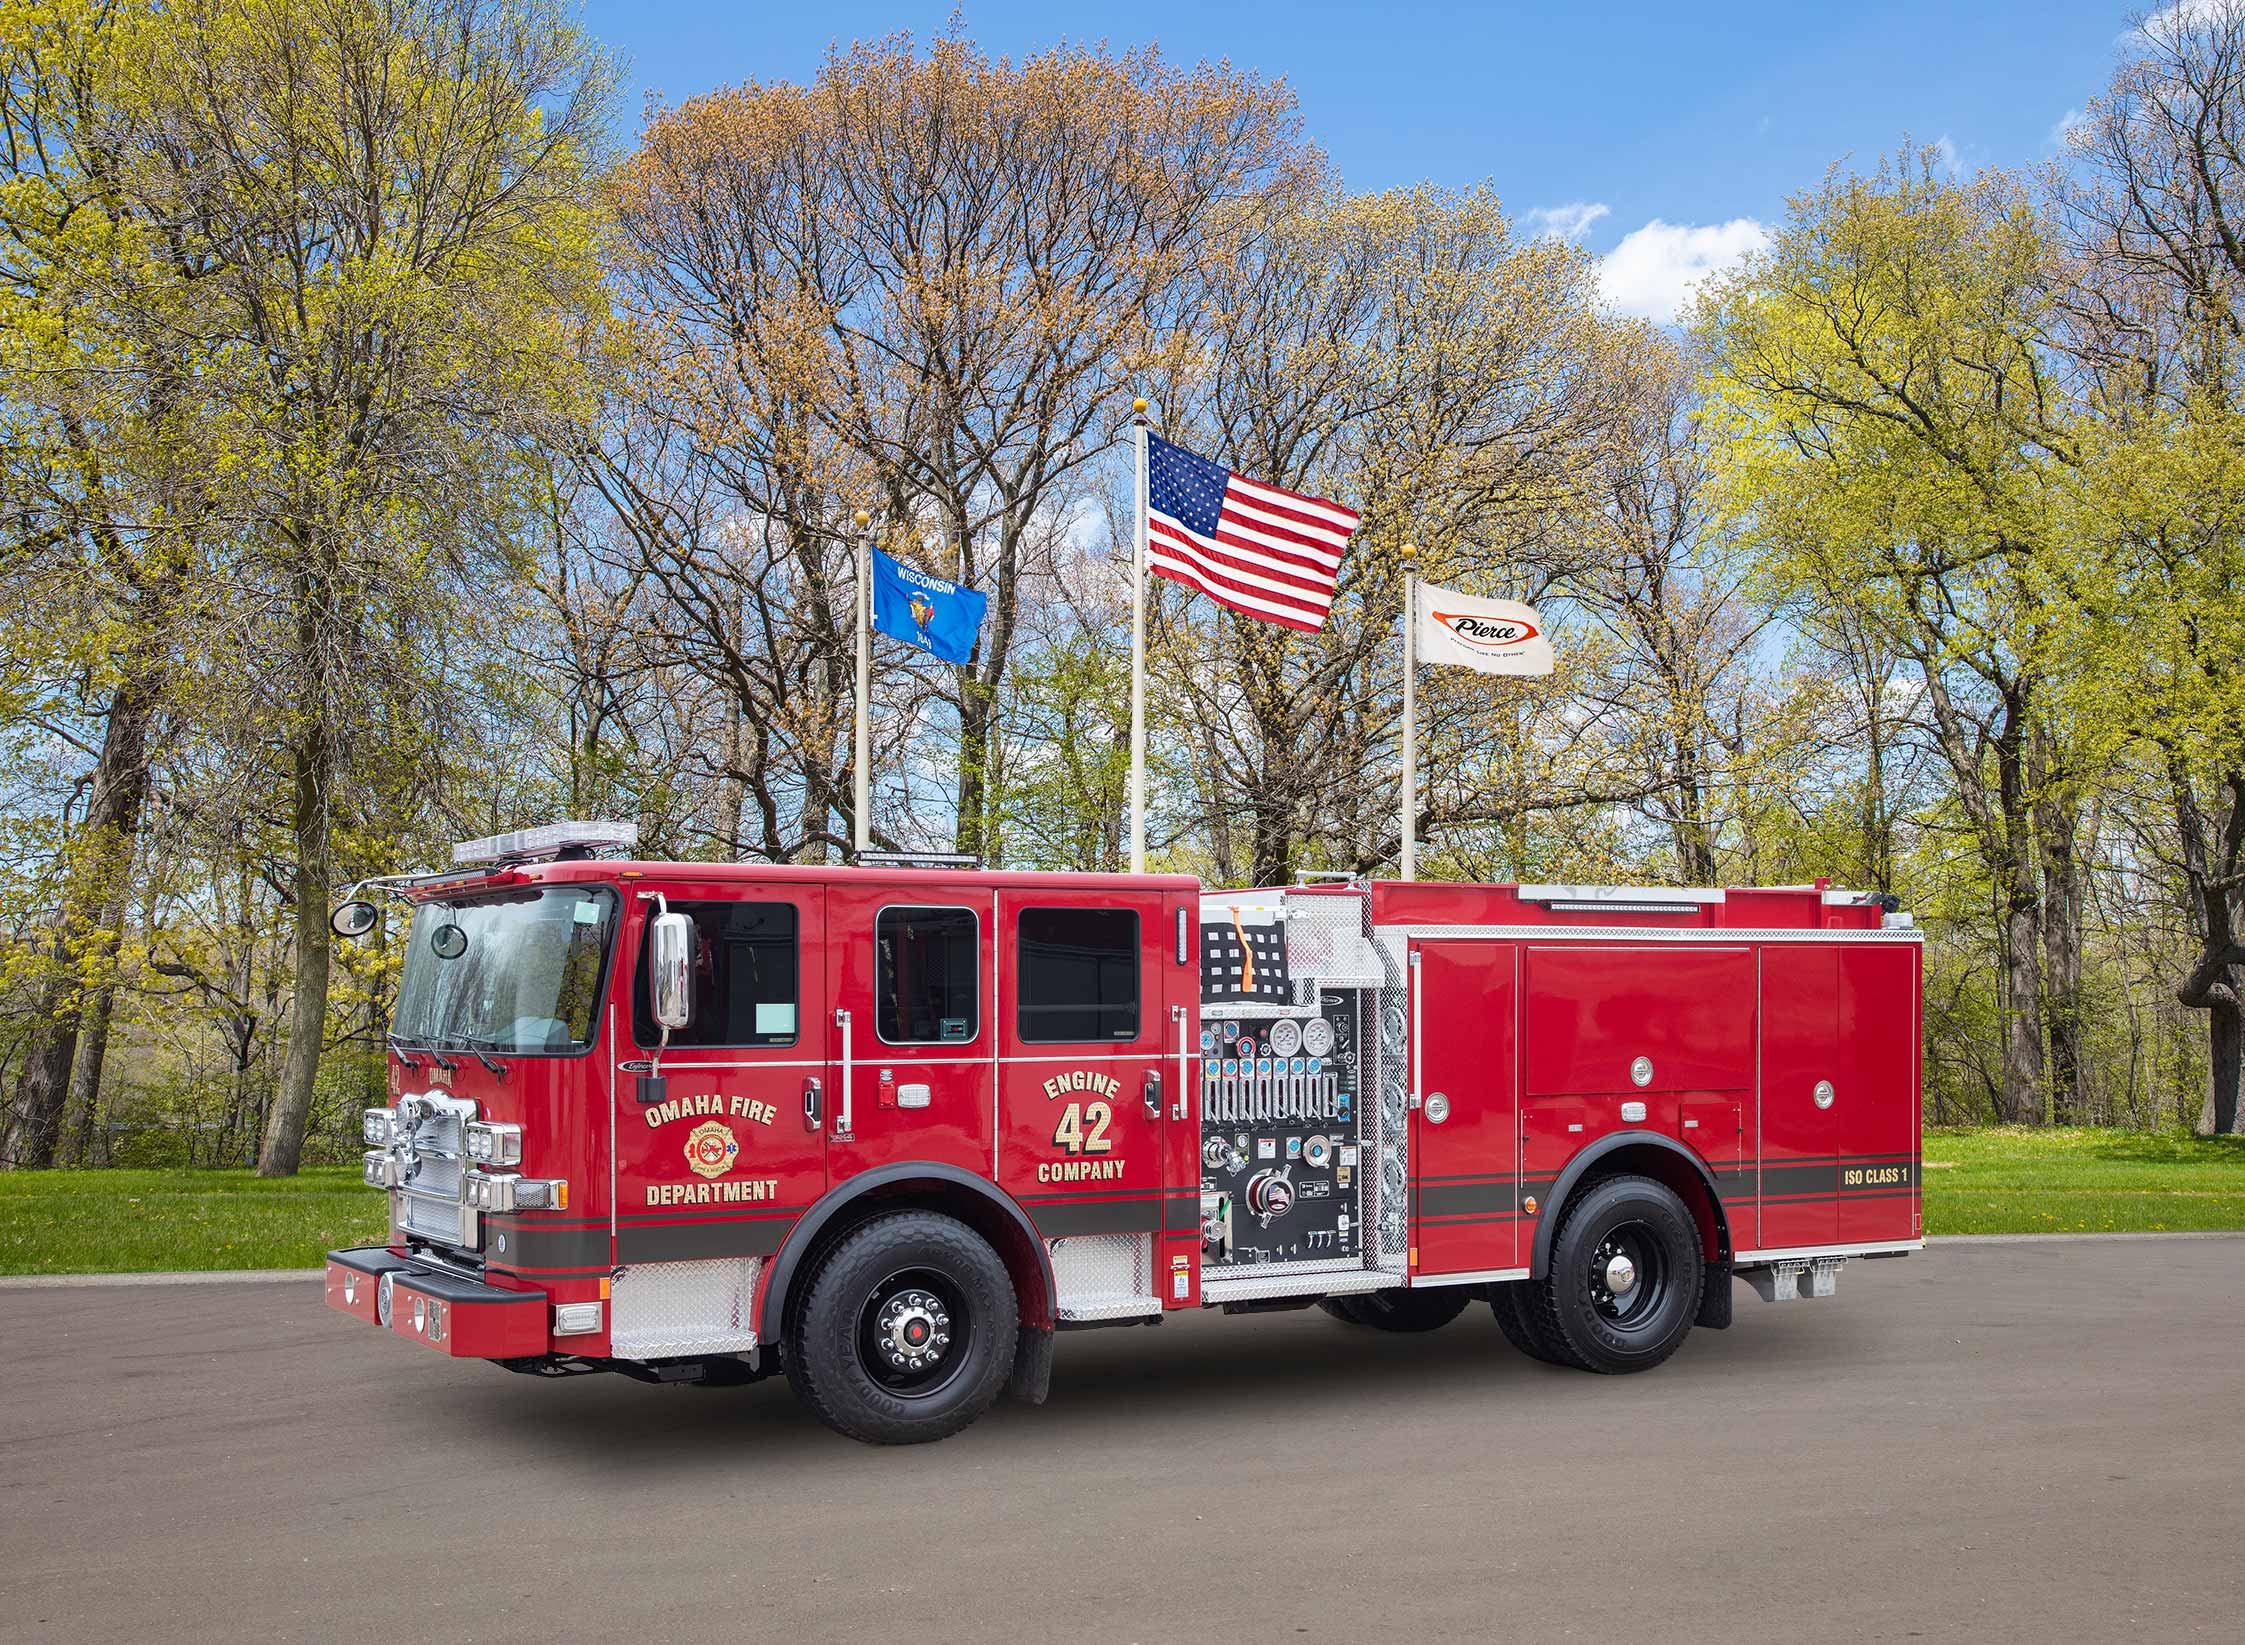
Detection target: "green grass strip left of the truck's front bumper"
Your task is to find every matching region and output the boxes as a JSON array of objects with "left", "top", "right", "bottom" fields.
[{"left": 0, "top": 1165, "right": 386, "bottom": 1275}]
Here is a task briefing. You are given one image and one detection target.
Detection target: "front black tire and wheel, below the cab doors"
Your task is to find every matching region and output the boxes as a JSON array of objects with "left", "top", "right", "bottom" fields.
[{"left": 786, "top": 1212, "right": 1019, "bottom": 1445}]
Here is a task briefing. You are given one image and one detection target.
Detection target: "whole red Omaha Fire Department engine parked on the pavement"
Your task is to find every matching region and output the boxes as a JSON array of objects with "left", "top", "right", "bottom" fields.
[{"left": 326, "top": 824, "right": 1922, "bottom": 1443}]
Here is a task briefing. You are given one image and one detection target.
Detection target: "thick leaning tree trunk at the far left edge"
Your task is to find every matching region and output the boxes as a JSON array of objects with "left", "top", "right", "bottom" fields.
[{"left": 0, "top": 667, "right": 157, "bottom": 1169}]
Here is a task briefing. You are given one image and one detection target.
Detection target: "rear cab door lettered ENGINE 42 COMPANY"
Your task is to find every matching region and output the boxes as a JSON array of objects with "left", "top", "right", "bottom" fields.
[{"left": 997, "top": 886, "right": 1199, "bottom": 1265}]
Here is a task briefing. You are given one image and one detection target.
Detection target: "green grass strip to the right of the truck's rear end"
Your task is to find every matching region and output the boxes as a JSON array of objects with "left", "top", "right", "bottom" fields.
[{"left": 1926, "top": 1127, "right": 2245, "bottom": 1234}]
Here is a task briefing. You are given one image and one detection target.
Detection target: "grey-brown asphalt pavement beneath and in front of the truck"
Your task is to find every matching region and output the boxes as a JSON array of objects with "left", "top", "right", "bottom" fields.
[{"left": 0, "top": 1239, "right": 2245, "bottom": 1645}]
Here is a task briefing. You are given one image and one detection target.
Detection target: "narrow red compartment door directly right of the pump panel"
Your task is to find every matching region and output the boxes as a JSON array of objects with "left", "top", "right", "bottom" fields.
[{"left": 1410, "top": 943, "right": 1522, "bottom": 1279}]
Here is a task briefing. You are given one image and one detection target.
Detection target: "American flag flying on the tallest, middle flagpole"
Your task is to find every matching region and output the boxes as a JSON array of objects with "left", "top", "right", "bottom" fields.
[{"left": 1145, "top": 433, "right": 1358, "bottom": 633}]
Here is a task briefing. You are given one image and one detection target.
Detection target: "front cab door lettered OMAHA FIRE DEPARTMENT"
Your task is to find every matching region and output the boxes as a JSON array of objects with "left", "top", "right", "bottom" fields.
[{"left": 613, "top": 880, "right": 831, "bottom": 1263}]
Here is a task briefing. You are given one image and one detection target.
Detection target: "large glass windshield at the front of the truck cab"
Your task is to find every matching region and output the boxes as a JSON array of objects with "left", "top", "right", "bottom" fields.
[{"left": 391, "top": 886, "right": 615, "bottom": 1055}]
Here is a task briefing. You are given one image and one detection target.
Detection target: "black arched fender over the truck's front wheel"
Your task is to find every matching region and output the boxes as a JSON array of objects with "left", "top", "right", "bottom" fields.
[{"left": 757, "top": 1160, "right": 1057, "bottom": 1342}]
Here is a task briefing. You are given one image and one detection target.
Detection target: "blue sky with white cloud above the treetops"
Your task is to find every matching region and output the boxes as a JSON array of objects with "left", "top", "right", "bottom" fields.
[{"left": 584, "top": 0, "right": 2128, "bottom": 319}]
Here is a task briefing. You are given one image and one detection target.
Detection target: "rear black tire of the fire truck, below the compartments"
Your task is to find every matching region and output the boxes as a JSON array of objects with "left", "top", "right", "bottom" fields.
[{"left": 1527, "top": 1176, "right": 1706, "bottom": 1376}]
